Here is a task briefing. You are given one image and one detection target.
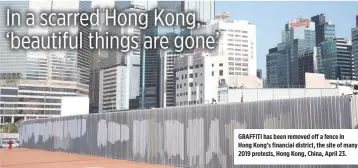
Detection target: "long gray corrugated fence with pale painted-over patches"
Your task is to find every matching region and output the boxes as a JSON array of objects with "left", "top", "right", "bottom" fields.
[{"left": 19, "top": 96, "right": 357, "bottom": 168}]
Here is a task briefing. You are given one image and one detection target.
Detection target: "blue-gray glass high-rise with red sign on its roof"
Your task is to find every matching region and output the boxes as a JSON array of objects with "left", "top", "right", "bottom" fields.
[{"left": 266, "top": 17, "right": 316, "bottom": 87}]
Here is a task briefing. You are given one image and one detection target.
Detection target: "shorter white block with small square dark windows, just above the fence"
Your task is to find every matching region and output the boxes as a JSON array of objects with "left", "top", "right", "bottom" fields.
[{"left": 175, "top": 53, "right": 228, "bottom": 106}]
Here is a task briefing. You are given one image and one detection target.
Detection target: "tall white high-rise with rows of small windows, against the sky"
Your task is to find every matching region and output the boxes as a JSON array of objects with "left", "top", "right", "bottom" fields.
[{"left": 193, "top": 17, "right": 257, "bottom": 76}]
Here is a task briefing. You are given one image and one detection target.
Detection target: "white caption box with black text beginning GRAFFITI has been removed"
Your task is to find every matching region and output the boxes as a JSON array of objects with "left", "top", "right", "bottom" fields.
[{"left": 234, "top": 129, "right": 358, "bottom": 165}]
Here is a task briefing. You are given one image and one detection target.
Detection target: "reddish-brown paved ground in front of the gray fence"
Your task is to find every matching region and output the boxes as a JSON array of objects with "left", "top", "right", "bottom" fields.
[{"left": 0, "top": 149, "right": 174, "bottom": 168}]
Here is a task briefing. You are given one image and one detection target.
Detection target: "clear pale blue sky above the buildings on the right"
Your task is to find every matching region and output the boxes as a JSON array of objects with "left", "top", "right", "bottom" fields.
[{"left": 215, "top": 1, "right": 358, "bottom": 76}]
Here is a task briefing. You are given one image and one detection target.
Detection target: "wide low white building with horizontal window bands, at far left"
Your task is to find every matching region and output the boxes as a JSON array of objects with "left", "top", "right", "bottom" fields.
[{"left": 0, "top": 79, "right": 88, "bottom": 122}]
